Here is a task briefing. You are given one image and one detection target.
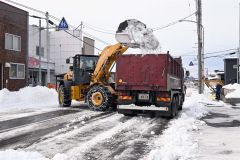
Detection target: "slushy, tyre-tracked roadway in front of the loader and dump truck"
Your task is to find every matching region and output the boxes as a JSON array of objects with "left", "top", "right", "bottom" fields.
[{"left": 0, "top": 105, "right": 169, "bottom": 160}]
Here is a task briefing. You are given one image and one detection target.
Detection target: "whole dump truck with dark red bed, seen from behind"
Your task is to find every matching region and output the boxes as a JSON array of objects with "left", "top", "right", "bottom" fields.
[{"left": 116, "top": 52, "right": 186, "bottom": 117}]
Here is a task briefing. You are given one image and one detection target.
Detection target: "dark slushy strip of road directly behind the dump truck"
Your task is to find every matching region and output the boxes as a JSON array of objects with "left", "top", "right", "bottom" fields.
[{"left": 83, "top": 117, "right": 168, "bottom": 160}]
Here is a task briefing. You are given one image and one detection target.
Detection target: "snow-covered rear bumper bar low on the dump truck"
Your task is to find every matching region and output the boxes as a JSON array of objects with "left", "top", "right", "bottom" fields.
[{"left": 118, "top": 105, "right": 169, "bottom": 111}]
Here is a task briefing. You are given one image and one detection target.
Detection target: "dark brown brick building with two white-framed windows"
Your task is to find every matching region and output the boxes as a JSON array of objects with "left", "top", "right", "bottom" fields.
[{"left": 0, "top": 1, "right": 28, "bottom": 90}]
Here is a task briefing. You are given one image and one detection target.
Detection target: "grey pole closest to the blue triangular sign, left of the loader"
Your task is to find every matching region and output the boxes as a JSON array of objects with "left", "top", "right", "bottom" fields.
[{"left": 45, "top": 12, "right": 50, "bottom": 85}]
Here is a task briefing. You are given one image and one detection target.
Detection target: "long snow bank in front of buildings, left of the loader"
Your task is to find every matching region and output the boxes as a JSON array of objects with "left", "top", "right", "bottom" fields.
[{"left": 0, "top": 86, "right": 58, "bottom": 112}]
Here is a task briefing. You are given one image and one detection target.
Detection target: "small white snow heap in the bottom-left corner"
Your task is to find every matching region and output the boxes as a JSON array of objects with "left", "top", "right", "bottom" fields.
[{"left": 0, "top": 149, "right": 49, "bottom": 160}]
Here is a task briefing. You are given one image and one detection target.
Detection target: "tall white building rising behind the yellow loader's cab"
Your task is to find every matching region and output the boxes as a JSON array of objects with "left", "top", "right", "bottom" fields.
[{"left": 50, "top": 30, "right": 94, "bottom": 74}]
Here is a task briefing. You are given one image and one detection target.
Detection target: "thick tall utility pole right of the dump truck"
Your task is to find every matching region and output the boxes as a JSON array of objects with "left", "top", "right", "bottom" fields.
[{"left": 197, "top": 0, "right": 203, "bottom": 94}]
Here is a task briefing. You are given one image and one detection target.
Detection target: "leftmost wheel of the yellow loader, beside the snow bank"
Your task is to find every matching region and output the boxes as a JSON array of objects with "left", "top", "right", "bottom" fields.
[{"left": 58, "top": 85, "right": 72, "bottom": 107}]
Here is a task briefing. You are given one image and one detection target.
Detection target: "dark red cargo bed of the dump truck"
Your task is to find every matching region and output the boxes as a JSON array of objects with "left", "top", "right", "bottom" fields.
[{"left": 116, "top": 54, "right": 183, "bottom": 91}]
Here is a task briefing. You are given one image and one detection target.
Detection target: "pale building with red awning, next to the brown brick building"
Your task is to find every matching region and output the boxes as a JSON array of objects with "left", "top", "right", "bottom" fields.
[{"left": 28, "top": 25, "right": 55, "bottom": 86}]
